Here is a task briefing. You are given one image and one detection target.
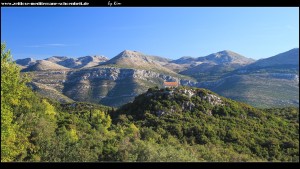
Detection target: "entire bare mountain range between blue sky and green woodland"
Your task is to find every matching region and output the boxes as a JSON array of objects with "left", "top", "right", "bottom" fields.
[{"left": 16, "top": 48, "right": 299, "bottom": 107}]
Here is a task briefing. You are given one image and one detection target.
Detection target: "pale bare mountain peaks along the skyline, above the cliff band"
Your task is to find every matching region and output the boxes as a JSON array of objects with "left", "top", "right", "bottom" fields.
[{"left": 16, "top": 50, "right": 254, "bottom": 73}]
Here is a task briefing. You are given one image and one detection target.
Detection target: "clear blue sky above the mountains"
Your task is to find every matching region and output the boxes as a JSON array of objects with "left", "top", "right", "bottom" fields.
[{"left": 1, "top": 7, "right": 299, "bottom": 59}]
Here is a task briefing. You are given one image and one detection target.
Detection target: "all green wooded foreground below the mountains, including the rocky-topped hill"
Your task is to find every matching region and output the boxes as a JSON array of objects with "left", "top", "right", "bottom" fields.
[{"left": 1, "top": 44, "right": 299, "bottom": 162}]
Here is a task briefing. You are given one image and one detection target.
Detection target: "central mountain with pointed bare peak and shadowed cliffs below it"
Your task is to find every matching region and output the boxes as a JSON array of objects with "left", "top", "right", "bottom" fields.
[{"left": 17, "top": 50, "right": 196, "bottom": 107}]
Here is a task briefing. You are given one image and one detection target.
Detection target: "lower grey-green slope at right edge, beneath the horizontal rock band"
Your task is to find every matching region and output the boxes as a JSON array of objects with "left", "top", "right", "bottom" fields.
[{"left": 197, "top": 73, "right": 299, "bottom": 107}]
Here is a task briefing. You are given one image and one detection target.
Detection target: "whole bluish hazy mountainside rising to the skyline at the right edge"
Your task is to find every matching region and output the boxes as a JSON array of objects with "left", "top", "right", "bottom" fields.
[{"left": 198, "top": 48, "right": 299, "bottom": 107}]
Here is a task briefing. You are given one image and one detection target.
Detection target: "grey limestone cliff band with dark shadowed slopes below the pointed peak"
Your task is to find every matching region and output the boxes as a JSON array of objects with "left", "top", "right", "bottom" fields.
[{"left": 33, "top": 67, "right": 197, "bottom": 107}]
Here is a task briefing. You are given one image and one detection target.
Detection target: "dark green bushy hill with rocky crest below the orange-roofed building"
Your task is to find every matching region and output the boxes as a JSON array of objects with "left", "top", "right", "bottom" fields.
[{"left": 113, "top": 87, "right": 299, "bottom": 161}]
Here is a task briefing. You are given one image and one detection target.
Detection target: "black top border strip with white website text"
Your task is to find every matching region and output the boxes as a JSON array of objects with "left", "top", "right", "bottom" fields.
[{"left": 1, "top": 0, "right": 300, "bottom": 7}]
